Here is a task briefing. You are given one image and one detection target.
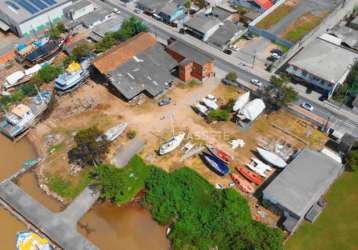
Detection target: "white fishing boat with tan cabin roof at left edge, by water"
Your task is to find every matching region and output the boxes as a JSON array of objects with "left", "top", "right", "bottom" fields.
[{"left": 0, "top": 91, "right": 52, "bottom": 139}]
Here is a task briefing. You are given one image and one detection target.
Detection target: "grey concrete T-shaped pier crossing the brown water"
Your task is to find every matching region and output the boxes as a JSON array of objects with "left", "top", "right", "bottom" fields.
[{"left": 0, "top": 180, "right": 99, "bottom": 250}]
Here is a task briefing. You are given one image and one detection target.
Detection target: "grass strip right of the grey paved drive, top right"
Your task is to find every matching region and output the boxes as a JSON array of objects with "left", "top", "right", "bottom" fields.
[{"left": 283, "top": 12, "right": 327, "bottom": 43}]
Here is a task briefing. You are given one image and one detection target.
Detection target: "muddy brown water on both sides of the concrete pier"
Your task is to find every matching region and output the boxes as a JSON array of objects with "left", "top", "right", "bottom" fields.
[{"left": 0, "top": 135, "right": 169, "bottom": 250}]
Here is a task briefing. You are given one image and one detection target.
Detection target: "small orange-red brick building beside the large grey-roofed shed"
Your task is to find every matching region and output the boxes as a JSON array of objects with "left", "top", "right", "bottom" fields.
[{"left": 167, "top": 41, "right": 214, "bottom": 81}]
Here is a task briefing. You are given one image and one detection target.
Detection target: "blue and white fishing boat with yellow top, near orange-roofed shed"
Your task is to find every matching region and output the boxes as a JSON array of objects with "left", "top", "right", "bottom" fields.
[{"left": 55, "top": 59, "right": 90, "bottom": 95}]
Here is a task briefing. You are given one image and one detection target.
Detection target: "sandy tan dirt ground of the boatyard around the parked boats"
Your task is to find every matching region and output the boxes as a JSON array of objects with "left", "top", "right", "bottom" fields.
[{"left": 29, "top": 79, "right": 326, "bottom": 224}]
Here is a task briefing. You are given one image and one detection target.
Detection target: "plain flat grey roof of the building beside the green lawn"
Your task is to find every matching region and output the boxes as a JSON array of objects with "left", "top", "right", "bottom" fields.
[{"left": 263, "top": 149, "right": 342, "bottom": 217}]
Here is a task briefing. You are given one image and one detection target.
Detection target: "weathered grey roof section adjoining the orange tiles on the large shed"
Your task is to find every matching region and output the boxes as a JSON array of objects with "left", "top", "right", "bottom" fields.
[{"left": 108, "top": 43, "right": 177, "bottom": 100}]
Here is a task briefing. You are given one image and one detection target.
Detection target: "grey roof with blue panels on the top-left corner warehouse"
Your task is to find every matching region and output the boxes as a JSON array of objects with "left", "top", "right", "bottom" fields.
[{"left": 0, "top": 0, "right": 71, "bottom": 24}]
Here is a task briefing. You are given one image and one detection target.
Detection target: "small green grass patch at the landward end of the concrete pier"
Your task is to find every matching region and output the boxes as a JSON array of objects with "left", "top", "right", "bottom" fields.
[{"left": 47, "top": 171, "right": 91, "bottom": 200}]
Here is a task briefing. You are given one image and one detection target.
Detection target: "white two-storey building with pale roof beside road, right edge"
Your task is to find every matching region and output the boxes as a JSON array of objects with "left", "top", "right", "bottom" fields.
[{"left": 286, "top": 38, "right": 358, "bottom": 97}]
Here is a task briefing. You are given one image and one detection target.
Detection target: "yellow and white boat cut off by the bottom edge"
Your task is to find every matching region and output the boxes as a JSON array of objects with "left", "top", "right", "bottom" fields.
[{"left": 16, "top": 231, "right": 53, "bottom": 250}]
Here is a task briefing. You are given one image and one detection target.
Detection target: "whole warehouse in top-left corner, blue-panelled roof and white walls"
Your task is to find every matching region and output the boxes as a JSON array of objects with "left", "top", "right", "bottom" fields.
[{"left": 0, "top": 0, "right": 72, "bottom": 36}]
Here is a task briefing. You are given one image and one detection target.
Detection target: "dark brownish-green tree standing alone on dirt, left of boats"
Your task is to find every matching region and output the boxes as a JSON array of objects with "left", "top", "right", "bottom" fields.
[{"left": 68, "top": 126, "right": 109, "bottom": 167}]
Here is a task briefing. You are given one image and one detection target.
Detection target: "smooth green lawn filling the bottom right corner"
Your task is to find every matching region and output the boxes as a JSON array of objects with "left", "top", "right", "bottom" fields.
[{"left": 285, "top": 172, "right": 358, "bottom": 250}]
